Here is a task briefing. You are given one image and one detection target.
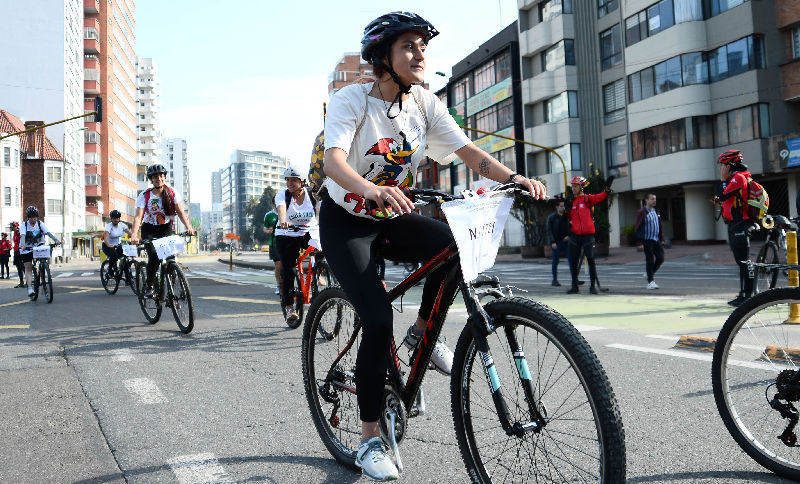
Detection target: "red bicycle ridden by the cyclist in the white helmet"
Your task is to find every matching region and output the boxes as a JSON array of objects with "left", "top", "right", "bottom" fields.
[{"left": 281, "top": 225, "right": 336, "bottom": 329}]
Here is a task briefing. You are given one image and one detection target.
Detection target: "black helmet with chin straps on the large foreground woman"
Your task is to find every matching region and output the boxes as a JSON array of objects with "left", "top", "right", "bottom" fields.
[{"left": 361, "top": 12, "right": 439, "bottom": 119}]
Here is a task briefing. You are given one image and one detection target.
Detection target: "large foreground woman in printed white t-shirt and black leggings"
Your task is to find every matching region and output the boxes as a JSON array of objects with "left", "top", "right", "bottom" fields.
[{"left": 320, "top": 12, "right": 545, "bottom": 481}]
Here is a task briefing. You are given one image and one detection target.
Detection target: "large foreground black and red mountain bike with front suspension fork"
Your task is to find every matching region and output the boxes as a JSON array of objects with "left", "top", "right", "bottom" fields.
[{"left": 302, "top": 185, "right": 626, "bottom": 483}]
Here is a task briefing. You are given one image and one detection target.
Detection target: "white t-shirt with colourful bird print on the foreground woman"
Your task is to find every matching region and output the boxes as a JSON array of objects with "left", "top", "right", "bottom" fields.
[{"left": 325, "top": 83, "right": 471, "bottom": 220}]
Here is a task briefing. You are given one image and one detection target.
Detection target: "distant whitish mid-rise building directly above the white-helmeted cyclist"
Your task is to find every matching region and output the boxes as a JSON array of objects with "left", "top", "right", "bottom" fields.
[{"left": 221, "top": 150, "right": 289, "bottom": 235}]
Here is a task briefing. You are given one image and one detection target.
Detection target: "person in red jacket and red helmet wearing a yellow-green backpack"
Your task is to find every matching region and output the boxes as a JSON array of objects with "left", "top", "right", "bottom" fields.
[{"left": 711, "top": 150, "right": 755, "bottom": 306}]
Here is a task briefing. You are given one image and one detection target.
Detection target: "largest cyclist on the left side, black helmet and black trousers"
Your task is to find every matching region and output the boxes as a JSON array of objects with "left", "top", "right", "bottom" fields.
[{"left": 131, "top": 164, "right": 194, "bottom": 298}]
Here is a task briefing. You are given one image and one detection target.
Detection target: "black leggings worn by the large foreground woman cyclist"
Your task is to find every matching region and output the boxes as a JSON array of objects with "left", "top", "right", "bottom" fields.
[{"left": 319, "top": 197, "right": 456, "bottom": 422}]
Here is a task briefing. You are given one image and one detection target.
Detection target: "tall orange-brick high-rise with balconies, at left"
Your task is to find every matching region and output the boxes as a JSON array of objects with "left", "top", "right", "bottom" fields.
[{"left": 83, "top": 0, "right": 140, "bottom": 230}]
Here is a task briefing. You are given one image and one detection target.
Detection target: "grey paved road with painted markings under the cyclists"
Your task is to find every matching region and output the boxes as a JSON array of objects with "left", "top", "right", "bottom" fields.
[{"left": 0, "top": 258, "right": 788, "bottom": 484}]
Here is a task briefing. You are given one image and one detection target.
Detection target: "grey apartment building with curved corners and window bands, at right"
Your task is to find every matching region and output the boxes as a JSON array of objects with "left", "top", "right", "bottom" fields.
[{"left": 519, "top": 0, "right": 797, "bottom": 246}]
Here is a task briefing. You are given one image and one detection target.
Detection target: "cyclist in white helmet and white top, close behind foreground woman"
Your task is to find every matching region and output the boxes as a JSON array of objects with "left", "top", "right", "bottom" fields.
[{"left": 275, "top": 166, "right": 321, "bottom": 322}]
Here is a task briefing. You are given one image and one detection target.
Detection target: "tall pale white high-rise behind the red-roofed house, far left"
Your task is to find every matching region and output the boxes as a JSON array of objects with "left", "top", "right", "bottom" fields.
[{"left": 0, "top": 0, "right": 87, "bottom": 255}]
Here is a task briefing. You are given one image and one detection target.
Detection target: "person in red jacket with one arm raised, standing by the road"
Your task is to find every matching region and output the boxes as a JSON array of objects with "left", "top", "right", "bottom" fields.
[{"left": 567, "top": 175, "right": 615, "bottom": 294}]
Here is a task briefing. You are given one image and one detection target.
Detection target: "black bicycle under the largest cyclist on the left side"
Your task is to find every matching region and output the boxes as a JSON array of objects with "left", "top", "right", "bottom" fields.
[{"left": 136, "top": 232, "right": 194, "bottom": 334}]
